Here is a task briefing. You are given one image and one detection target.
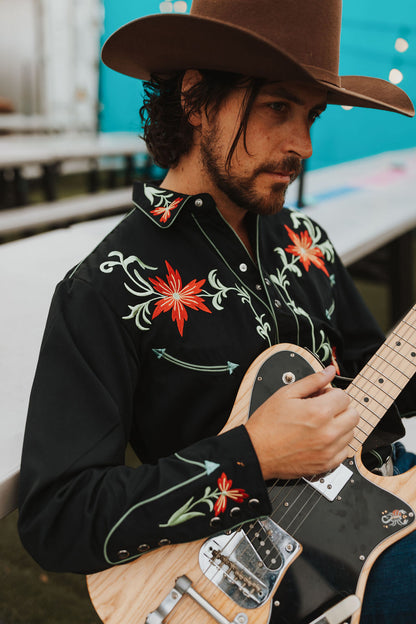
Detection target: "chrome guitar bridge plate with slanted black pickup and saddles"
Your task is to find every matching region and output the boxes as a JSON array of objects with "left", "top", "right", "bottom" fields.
[{"left": 199, "top": 518, "right": 301, "bottom": 609}]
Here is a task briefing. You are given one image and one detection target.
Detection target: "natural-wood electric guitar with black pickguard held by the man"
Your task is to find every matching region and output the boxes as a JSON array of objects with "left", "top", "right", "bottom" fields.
[{"left": 87, "top": 306, "right": 416, "bottom": 624}]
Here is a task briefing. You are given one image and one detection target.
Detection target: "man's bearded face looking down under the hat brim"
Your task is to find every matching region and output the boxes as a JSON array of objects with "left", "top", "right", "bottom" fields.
[{"left": 200, "top": 82, "right": 326, "bottom": 214}]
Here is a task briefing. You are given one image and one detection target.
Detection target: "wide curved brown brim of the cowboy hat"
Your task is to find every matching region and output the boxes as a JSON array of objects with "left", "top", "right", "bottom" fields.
[{"left": 102, "top": 13, "right": 415, "bottom": 117}]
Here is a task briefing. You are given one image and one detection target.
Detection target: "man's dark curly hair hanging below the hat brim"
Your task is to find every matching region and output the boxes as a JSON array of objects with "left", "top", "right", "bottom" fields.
[{"left": 140, "top": 70, "right": 265, "bottom": 169}]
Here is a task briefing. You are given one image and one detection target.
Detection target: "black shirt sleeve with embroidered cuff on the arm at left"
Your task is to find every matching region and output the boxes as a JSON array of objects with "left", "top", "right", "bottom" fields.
[{"left": 19, "top": 279, "right": 271, "bottom": 573}]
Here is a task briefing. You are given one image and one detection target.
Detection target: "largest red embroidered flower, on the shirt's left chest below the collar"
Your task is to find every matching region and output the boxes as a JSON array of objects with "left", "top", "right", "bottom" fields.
[{"left": 149, "top": 261, "right": 211, "bottom": 336}]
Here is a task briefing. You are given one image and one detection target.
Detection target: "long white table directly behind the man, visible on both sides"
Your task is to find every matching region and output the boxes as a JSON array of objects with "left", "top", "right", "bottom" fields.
[{"left": 0, "top": 151, "right": 416, "bottom": 517}]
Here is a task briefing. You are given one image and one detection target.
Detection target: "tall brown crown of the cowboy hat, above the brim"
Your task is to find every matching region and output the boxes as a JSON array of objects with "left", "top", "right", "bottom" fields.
[{"left": 191, "top": 0, "right": 342, "bottom": 84}]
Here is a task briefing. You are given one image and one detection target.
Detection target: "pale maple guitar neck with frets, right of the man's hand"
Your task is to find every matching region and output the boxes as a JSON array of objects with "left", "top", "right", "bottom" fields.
[{"left": 347, "top": 305, "right": 416, "bottom": 451}]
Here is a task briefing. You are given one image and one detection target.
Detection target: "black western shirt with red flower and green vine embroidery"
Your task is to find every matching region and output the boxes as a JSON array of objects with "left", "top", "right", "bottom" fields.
[{"left": 19, "top": 183, "right": 410, "bottom": 573}]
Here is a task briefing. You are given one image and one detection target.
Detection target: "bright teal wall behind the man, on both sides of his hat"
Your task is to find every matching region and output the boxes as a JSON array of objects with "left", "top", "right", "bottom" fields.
[{"left": 100, "top": 0, "right": 416, "bottom": 168}]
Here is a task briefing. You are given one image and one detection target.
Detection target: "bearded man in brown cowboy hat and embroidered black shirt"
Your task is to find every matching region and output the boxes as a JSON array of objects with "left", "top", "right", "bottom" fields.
[{"left": 19, "top": 0, "right": 415, "bottom": 622}]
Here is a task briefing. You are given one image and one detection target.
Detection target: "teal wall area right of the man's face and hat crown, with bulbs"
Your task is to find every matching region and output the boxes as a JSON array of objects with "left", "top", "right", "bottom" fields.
[{"left": 310, "top": 0, "right": 416, "bottom": 168}]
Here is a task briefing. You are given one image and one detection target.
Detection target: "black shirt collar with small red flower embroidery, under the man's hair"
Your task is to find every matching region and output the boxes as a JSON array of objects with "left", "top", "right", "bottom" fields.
[{"left": 133, "top": 182, "right": 207, "bottom": 229}]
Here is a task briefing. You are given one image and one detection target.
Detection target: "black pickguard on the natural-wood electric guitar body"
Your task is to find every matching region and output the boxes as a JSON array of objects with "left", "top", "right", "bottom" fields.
[{"left": 250, "top": 351, "right": 414, "bottom": 624}]
